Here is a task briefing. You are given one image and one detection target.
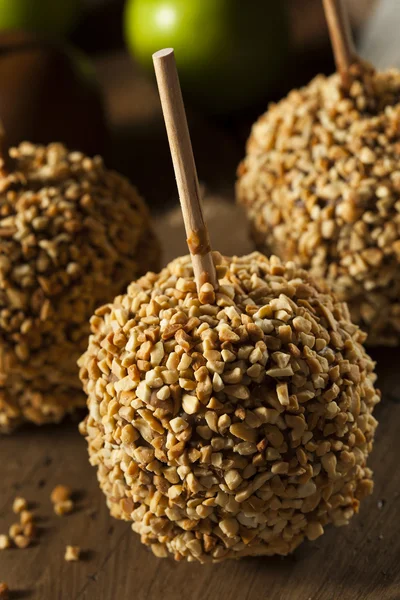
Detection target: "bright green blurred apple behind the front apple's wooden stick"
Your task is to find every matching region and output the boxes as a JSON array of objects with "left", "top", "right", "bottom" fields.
[{"left": 125, "top": 0, "right": 289, "bottom": 114}]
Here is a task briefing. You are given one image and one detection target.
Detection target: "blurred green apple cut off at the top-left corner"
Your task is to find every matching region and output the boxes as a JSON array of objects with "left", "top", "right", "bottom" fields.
[{"left": 0, "top": 0, "right": 82, "bottom": 38}]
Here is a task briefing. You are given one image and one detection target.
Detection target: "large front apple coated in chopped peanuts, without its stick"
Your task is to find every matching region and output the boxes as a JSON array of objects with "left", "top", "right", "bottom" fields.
[{"left": 79, "top": 252, "right": 380, "bottom": 563}]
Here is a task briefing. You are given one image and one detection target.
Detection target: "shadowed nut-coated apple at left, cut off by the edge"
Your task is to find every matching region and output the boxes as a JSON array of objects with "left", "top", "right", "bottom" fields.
[{"left": 0, "top": 142, "right": 160, "bottom": 433}]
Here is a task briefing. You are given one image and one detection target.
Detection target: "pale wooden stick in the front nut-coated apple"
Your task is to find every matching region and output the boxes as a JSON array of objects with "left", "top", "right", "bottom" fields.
[{"left": 153, "top": 48, "right": 218, "bottom": 292}]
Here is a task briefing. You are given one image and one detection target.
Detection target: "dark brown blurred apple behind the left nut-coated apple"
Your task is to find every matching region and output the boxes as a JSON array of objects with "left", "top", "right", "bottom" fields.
[{"left": 0, "top": 31, "right": 107, "bottom": 155}]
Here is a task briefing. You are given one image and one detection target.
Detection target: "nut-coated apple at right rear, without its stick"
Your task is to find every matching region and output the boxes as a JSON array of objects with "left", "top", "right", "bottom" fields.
[{"left": 237, "top": 64, "right": 400, "bottom": 345}]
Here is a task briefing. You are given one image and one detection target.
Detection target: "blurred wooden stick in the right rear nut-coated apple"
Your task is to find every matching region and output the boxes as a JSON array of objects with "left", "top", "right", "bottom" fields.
[{"left": 323, "top": 0, "right": 357, "bottom": 87}]
